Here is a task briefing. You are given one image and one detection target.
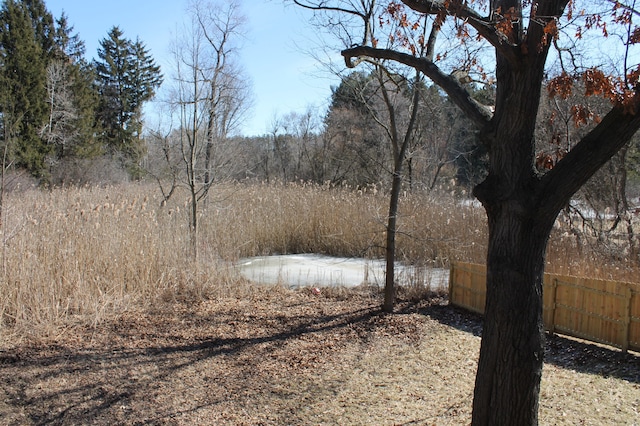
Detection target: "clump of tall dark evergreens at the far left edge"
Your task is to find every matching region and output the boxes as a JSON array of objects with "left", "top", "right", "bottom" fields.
[{"left": 0, "top": 0, "right": 97, "bottom": 180}]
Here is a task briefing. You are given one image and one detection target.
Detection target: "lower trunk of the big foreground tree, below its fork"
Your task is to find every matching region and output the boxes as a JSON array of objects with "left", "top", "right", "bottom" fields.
[{"left": 472, "top": 202, "right": 549, "bottom": 425}]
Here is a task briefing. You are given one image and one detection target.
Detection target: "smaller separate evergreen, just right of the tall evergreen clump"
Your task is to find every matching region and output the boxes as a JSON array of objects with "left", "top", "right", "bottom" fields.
[{"left": 95, "top": 27, "right": 162, "bottom": 173}]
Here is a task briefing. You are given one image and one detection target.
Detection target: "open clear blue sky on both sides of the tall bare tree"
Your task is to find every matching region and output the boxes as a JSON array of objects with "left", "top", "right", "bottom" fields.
[{"left": 45, "top": 0, "right": 339, "bottom": 136}]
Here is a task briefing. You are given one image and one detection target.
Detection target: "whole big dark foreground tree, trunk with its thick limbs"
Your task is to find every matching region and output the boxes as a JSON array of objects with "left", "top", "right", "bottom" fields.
[{"left": 342, "top": 0, "right": 640, "bottom": 426}]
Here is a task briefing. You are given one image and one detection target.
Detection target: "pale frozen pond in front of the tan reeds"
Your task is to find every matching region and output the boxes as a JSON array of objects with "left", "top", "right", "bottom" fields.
[{"left": 237, "top": 254, "right": 449, "bottom": 289}]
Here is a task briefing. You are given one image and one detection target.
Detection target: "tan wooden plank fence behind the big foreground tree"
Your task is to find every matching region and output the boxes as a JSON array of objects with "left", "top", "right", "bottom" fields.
[{"left": 449, "top": 262, "right": 640, "bottom": 351}]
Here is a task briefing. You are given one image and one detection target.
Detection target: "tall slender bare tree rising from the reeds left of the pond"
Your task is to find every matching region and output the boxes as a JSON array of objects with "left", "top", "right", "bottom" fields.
[{"left": 165, "top": 1, "right": 249, "bottom": 258}]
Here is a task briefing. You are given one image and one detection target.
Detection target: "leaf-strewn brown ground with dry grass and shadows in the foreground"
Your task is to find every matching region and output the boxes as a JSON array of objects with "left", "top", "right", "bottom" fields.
[{"left": 0, "top": 290, "right": 640, "bottom": 425}]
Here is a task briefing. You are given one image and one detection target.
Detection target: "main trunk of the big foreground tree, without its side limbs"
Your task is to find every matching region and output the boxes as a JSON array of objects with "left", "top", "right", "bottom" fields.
[{"left": 472, "top": 38, "right": 560, "bottom": 426}]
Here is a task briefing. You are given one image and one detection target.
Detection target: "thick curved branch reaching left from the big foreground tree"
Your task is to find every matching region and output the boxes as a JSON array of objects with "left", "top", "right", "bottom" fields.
[{"left": 341, "top": 46, "right": 493, "bottom": 126}]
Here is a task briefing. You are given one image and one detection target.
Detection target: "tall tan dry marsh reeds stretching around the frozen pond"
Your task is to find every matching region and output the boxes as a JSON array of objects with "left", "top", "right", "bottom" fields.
[{"left": 0, "top": 183, "right": 637, "bottom": 336}]
